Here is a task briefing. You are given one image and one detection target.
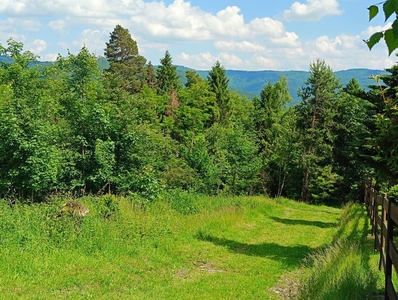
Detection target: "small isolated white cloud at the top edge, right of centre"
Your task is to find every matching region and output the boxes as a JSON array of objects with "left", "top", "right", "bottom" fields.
[{"left": 283, "top": 0, "right": 342, "bottom": 21}]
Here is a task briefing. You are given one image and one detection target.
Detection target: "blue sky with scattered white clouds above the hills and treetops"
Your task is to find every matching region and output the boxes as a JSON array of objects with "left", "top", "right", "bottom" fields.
[{"left": 0, "top": 0, "right": 398, "bottom": 71}]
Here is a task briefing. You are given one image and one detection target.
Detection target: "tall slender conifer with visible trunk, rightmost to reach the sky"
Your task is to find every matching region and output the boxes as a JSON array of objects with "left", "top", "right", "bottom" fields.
[{"left": 297, "top": 59, "right": 341, "bottom": 202}]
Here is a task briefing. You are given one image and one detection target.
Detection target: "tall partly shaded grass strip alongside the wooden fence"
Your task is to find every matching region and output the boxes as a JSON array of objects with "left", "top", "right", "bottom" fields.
[{"left": 298, "top": 203, "right": 384, "bottom": 300}]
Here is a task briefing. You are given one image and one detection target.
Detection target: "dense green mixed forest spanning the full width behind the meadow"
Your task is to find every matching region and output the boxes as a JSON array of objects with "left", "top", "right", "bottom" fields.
[{"left": 0, "top": 25, "right": 398, "bottom": 205}]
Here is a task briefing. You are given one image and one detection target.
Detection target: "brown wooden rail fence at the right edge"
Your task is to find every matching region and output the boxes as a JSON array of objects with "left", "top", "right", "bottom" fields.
[{"left": 362, "top": 182, "right": 398, "bottom": 300}]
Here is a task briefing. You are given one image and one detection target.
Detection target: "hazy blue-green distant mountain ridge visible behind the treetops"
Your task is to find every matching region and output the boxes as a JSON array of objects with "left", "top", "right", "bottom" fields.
[{"left": 0, "top": 55, "right": 386, "bottom": 104}]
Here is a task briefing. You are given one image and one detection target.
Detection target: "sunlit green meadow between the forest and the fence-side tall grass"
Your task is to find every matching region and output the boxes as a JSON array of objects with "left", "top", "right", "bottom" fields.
[{"left": 0, "top": 196, "right": 352, "bottom": 299}]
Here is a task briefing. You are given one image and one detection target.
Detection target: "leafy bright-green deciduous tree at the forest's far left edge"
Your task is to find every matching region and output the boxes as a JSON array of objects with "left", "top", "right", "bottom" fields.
[{"left": 0, "top": 39, "right": 61, "bottom": 199}]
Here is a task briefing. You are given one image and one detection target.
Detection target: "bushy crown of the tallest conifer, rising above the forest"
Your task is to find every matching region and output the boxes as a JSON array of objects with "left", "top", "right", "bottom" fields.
[{"left": 104, "top": 25, "right": 146, "bottom": 94}]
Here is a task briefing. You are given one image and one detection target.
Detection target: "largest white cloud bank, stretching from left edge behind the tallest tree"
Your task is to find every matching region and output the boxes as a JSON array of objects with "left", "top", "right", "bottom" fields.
[{"left": 0, "top": 0, "right": 299, "bottom": 62}]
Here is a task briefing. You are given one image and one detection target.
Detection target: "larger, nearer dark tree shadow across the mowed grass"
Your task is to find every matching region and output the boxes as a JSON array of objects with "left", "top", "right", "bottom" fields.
[{"left": 197, "top": 232, "right": 313, "bottom": 268}]
